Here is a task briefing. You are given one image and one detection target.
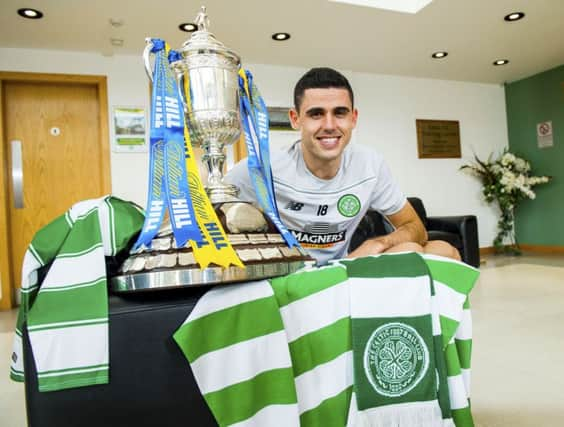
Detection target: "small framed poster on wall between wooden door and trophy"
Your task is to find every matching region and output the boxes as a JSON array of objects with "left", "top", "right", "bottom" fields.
[{"left": 112, "top": 107, "right": 148, "bottom": 153}]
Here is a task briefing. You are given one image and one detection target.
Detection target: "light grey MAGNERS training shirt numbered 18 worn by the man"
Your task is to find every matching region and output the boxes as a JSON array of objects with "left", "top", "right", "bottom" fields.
[{"left": 226, "top": 141, "right": 406, "bottom": 264}]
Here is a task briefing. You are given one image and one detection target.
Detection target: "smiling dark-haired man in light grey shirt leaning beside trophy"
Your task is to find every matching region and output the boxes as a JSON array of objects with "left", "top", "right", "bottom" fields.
[{"left": 226, "top": 68, "right": 460, "bottom": 264}]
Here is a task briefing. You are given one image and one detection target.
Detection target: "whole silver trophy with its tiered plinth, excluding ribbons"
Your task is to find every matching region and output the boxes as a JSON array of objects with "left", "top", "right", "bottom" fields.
[{"left": 111, "top": 7, "right": 312, "bottom": 292}]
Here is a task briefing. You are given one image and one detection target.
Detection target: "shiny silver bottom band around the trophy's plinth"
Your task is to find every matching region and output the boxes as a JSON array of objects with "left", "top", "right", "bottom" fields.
[{"left": 110, "top": 261, "right": 305, "bottom": 293}]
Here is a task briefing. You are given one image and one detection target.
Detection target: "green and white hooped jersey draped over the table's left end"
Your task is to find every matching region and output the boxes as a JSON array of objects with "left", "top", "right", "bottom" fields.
[{"left": 10, "top": 196, "right": 143, "bottom": 391}]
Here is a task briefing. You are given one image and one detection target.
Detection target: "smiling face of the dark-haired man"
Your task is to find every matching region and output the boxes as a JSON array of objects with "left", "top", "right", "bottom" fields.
[{"left": 290, "top": 88, "right": 358, "bottom": 173}]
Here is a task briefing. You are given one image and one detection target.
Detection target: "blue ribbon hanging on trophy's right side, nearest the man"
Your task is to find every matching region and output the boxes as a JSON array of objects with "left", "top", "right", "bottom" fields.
[{"left": 239, "top": 71, "right": 300, "bottom": 247}]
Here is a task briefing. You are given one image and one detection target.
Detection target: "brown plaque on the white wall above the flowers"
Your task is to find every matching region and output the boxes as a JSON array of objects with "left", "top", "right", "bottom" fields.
[{"left": 415, "top": 119, "right": 461, "bottom": 159}]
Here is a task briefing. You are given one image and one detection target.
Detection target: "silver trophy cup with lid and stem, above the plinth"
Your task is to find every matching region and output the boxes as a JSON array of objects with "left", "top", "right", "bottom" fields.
[{"left": 165, "top": 7, "right": 241, "bottom": 203}]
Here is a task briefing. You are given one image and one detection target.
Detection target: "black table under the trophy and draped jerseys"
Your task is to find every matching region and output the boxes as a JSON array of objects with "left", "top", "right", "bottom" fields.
[{"left": 23, "top": 288, "right": 217, "bottom": 427}]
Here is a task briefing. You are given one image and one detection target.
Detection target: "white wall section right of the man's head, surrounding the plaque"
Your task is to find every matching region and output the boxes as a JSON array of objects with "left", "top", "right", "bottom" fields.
[{"left": 351, "top": 74, "right": 508, "bottom": 246}]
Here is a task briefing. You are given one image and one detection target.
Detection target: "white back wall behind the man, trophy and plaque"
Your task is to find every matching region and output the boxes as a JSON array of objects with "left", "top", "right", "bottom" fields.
[{"left": 0, "top": 49, "right": 507, "bottom": 246}]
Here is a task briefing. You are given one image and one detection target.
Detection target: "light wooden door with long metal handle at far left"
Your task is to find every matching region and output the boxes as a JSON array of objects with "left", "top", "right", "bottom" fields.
[{"left": 2, "top": 81, "right": 108, "bottom": 308}]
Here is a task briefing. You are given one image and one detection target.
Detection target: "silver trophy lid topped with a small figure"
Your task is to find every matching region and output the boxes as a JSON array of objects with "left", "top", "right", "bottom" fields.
[{"left": 180, "top": 6, "right": 241, "bottom": 65}]
